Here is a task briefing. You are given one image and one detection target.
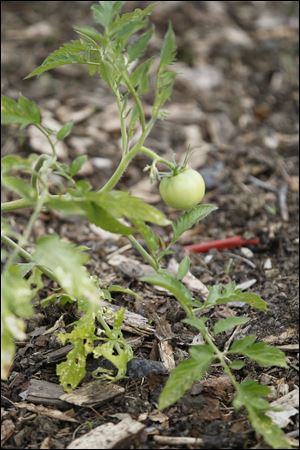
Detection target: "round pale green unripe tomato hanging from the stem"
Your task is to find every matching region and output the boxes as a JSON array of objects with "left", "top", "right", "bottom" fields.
[{"left": 159, "top": 169, "right": 205, "bottom": 209}]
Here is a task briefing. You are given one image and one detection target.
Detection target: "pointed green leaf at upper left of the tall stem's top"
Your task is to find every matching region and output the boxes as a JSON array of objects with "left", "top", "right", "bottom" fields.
[{"left": 25, "top": 40, "right": 90, "bottom": 80}]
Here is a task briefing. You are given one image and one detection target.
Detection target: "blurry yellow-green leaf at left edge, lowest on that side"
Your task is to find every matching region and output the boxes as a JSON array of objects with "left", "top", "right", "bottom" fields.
[{"left": 1, "top": 266, "right": 35, "bottom": 379}]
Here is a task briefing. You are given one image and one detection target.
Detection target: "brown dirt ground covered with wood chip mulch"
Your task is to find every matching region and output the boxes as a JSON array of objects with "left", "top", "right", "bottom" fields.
[{"left": 1, "top": 1, "right": 299, "bottom": 449}]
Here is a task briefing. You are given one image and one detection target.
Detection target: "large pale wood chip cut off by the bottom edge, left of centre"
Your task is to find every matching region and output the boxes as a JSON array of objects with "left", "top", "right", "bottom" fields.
[{"left": 67, "top": 417, "right": 145, "bottom": 449}]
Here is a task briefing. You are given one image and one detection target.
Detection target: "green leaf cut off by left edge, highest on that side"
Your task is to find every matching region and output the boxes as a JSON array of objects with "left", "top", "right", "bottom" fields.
[{"left": 1, "top": 95, "right": 41, "bottom": 128}]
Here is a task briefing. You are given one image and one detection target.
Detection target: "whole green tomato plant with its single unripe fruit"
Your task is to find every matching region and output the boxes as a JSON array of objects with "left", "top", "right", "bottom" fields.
[{"left": 1, "top": 1, "right": 289, "bottom": 448}]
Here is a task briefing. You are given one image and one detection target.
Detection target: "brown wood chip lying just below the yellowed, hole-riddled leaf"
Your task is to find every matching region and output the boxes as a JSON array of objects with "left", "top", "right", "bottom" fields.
[{"left": 60, "top": 380, "right": 125, "bottom": 407}]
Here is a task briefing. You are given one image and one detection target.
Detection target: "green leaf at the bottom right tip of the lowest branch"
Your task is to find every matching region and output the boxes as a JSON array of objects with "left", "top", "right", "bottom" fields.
[{"left": 233, "top": 380, "right": 291, "bottom": 449}]
